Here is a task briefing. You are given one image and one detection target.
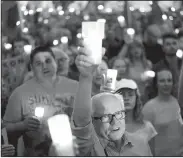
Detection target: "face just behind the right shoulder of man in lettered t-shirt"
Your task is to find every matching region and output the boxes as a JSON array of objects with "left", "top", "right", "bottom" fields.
[{"left": 56, "top": 52, "right": 69, "bottom": 75}]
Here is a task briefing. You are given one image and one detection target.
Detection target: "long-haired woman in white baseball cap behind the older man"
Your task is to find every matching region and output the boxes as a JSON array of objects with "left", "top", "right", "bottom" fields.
[{"left": 116, "top": 79, "right": 157, "bottom": 155}]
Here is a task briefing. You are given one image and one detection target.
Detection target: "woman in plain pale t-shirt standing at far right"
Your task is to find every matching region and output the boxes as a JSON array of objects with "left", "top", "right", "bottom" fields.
[{"left": 142, "top": 69, "right": 183, "bottom": 156}]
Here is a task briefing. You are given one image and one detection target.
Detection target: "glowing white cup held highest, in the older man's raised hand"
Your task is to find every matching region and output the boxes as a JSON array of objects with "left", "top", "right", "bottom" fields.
[{"left": 82, "top": 21, "right": 105, "bottom": 65}]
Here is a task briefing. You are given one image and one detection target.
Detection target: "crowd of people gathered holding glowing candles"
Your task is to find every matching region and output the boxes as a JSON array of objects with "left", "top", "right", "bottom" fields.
[{"left": 1, "top": 3, "right": 183, "bottom": 156}]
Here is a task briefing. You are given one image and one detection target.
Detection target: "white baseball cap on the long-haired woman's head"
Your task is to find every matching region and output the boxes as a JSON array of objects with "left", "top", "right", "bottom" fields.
[{"left": 116, "top": 79, "right": 138, "bottom": 91}]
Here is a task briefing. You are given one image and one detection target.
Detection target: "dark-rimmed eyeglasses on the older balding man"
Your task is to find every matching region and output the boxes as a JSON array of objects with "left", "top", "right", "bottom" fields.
[{"left": 93, "top": 110, "right": 125, "bottom": 123}]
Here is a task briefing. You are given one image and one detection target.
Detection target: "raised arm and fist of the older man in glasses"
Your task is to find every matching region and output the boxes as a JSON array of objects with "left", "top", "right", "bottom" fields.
[{"left": 71, "top": 45, "right": 98, "bottom": 156}]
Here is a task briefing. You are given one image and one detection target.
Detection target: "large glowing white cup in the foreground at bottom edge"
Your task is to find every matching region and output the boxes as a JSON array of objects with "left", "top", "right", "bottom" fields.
[{"left": 48, "top": 114, "right": 75, "bottom": 156}]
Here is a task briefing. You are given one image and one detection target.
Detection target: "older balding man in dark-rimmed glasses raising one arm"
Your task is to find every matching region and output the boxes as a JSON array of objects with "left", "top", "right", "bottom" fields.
[{"left": 71, "top": 47, "right": 151, "bottom": 156}]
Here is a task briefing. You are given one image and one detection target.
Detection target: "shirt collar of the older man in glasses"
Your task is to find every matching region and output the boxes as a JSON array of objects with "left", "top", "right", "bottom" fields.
[{"left": 99, "top": 132, "right": 133, "bottom": 149}]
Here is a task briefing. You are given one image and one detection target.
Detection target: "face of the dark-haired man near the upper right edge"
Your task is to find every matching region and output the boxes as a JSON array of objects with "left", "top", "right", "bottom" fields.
[{"left": 163, "top": 38, "right": 178, "bottom": 55}]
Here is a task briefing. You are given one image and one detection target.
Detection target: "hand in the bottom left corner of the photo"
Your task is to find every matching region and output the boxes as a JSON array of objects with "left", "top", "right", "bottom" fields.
[{"left": 1, "top": 144, "right": 15, "bottom": 157}]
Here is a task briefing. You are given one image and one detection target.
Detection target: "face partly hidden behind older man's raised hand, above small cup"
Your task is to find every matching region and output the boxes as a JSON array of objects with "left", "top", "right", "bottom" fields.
[{"left": 93, "top": 61, "right": 108, "bottom": 86}]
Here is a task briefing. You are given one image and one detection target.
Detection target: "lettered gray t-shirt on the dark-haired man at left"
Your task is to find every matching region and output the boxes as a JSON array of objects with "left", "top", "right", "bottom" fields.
[{"left": 4, "top": 77, "right": 78, "bottom": 156}]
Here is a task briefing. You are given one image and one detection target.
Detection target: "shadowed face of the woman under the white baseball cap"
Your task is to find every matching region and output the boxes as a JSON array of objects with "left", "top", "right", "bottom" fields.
[{"left": 121, "top": 88, "right": 137, "bottom": 111}]
